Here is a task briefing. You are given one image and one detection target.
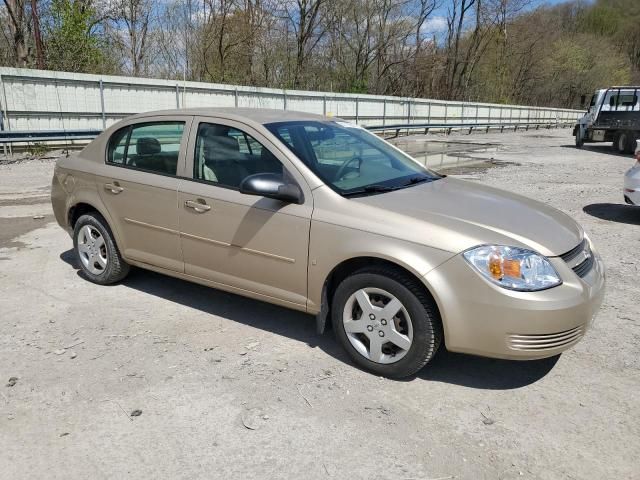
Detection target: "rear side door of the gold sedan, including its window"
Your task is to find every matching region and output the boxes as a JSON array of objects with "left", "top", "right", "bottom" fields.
[{"left": 96, "top": 116, "right": 192, "bottom": 272}]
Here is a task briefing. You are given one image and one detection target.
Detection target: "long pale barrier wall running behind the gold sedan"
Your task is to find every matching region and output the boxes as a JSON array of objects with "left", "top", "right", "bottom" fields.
[{"left": 0, "top": 67, "right": 583, "bottom": 130}]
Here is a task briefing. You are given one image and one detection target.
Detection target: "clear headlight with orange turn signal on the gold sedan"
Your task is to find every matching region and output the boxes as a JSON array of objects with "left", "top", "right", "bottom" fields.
[{"left": 463, "top": 245, "right": 562, "bottom": 292}]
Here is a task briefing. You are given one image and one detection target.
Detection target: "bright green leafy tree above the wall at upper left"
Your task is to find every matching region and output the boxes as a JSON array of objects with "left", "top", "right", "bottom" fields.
[{"left": 44, "top": 0, "right": 107, "bottom": 72}]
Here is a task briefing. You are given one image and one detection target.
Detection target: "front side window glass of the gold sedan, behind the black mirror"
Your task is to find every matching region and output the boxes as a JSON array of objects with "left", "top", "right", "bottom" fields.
[{"left": 193, "top": 122, "right": 283, "bottom": 190}]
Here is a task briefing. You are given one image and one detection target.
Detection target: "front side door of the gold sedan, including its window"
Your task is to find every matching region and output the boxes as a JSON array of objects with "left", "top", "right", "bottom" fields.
[{"left": 178, "top": 118, "right": 313, "bottom": 309}]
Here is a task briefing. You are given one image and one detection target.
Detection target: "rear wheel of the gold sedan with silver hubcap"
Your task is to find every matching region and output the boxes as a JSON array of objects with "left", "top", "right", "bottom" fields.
[{"left": 73, "top": 212, "right": 130, "bottom": 285}]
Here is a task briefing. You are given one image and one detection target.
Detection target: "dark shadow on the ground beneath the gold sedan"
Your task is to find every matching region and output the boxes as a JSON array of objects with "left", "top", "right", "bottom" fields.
[{"left": 60, "top": 250, "right": 560, "bottom": 390}]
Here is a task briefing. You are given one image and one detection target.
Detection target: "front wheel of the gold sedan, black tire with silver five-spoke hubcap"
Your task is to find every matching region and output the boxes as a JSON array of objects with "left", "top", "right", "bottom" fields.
[{"left": 331, "top": 267, "right": 443, "bottom": 378}]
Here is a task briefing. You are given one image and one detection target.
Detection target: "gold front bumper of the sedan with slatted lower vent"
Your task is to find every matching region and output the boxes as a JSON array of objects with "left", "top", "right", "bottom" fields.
[{"left": 424, "top": 246, "right": 605, "bottom": 360}]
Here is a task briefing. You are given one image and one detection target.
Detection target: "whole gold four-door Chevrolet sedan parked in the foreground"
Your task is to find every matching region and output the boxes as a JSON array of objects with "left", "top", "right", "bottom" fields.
[{"left": 51, "top": 108, "right": 605, "bottom": 378}]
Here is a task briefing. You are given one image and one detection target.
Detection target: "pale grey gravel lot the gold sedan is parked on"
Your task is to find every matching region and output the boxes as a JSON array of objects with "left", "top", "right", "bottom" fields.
[{"left": 0, "top": 130, "right": 640, "bottom": 480}]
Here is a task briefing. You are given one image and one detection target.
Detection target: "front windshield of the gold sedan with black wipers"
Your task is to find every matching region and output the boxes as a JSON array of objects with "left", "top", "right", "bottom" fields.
[{"left": 266, "top": 121, "right": 441, "bottom": 196}]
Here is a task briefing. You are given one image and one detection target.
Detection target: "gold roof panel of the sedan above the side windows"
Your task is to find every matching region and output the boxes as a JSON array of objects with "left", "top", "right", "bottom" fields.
[{"left": 130, "top": 107, "right": 335, "bottom": 125}]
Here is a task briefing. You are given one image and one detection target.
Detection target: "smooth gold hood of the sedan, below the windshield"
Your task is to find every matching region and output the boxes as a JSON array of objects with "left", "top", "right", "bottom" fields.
[{"left": 350, "top": 177, "right": 584, "bottom": 256}]
